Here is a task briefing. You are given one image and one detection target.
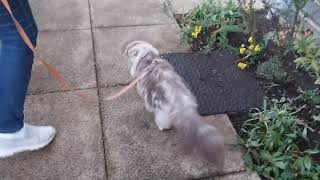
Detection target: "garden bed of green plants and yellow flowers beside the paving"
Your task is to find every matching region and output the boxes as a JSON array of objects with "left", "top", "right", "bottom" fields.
[{"left": 172, "top": 0, "right": 320, "bottom": 179}]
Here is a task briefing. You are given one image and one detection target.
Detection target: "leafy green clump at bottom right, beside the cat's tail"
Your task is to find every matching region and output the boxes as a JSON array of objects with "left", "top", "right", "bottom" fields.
[{"left": 238, "top": 98, "right": 320, "bottom": 180}]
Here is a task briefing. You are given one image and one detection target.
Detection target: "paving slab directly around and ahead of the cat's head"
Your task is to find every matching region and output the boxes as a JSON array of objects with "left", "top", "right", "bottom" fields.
[{"left": 93, "top": 24, "right": 189, "bottom": 87}]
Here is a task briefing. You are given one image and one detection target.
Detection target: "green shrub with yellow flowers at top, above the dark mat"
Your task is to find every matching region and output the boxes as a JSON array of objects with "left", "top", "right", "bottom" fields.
[{"left": 180, "top": 0, "right": 245, "bottom": 51}]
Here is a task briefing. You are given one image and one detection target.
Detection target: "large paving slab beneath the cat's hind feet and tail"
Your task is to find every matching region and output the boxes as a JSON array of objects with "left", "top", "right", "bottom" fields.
[{"left": 101, "top": 88, "right": 244, "bottom": 180}]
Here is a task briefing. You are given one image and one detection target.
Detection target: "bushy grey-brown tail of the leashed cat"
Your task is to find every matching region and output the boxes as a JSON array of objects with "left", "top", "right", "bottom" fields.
[{"left": 174, "top": 112, "right": 225, "bottom": 169}]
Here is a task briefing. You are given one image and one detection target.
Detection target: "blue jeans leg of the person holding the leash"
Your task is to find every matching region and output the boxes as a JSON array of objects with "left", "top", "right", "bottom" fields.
[{"left": 0, "top": 0, "right": 38, "bottom": 133}]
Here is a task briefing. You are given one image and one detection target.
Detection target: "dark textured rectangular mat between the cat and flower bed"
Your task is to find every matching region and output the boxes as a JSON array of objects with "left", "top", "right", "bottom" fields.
[{"left": 162, "top": 52, "right": 264, "bottom": 115}]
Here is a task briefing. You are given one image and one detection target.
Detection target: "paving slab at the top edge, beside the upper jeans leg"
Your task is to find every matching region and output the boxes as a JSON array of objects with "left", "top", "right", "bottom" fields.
[{"left": 30, "top": 0, "right": 90, "bottom": 30}]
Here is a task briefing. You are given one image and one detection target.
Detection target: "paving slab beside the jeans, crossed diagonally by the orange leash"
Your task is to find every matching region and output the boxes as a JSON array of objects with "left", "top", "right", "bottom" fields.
[{"left": 29, "top": 30, "right": 97, "bottom": 94}]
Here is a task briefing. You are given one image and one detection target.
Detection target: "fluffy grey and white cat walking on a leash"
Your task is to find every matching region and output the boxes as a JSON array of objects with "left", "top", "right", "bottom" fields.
[{"left": 125, "top": 41, "right": 225, "bottom": 168}]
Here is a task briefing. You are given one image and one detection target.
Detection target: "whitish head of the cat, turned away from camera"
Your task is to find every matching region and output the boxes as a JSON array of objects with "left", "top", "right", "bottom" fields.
[{"left": 124, "top": 41, "right": 159, "bottom": 77}]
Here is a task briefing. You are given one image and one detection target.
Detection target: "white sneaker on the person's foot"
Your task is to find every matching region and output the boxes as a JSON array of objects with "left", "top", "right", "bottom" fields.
[{"left": 0, "top": 123, "right": 56, "bottom": 158}]
